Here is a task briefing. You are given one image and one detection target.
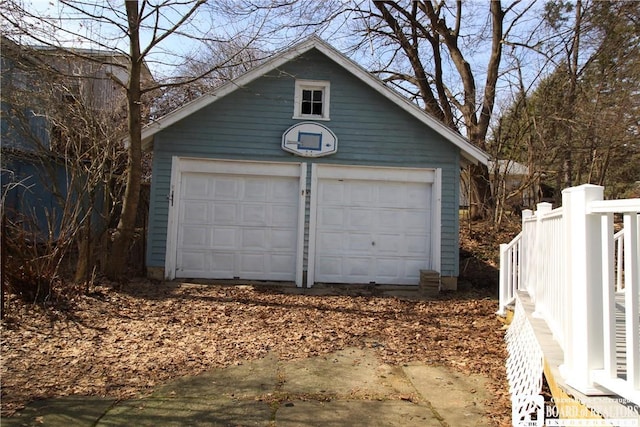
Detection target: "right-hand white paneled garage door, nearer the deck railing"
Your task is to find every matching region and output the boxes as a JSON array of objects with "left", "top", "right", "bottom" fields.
[{"left": 312, "top": 168, "right": 433, "bottom": 284}]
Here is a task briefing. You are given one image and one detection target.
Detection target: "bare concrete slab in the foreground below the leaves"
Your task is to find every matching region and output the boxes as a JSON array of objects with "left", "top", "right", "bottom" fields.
[{"left": 2, "top": 348, "right": 489, "bottom": 427}]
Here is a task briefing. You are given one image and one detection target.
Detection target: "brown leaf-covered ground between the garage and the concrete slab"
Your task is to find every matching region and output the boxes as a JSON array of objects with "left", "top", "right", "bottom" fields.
[{"left": 1, "top": 281, "right": 510, "bottom": 425}]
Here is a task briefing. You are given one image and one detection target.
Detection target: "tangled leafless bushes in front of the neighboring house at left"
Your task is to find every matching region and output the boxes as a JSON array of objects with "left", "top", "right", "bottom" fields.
[{"left": 2, "top": 39, "right": 126, "bottom": 293}]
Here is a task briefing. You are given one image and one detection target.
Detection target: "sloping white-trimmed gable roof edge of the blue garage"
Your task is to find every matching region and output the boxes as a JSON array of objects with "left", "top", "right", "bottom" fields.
[{"left": 142, "top": 36, "right": 489, "bottom": 165}]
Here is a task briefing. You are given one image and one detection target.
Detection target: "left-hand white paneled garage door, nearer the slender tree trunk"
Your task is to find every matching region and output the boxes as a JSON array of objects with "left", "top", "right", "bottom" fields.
[{"left": 175, "top": 159, "right": 300, "bottom": 281}]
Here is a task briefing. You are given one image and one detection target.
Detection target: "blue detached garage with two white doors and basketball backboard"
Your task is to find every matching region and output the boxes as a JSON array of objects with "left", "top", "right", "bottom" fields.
[{"left": 142, "top": 37, "right": 489, "bottom": 289}]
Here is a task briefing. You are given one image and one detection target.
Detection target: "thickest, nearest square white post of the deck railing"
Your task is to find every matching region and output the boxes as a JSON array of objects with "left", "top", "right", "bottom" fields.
[{"left": 561, "top": 184, "right": 604, "bottom": 394}]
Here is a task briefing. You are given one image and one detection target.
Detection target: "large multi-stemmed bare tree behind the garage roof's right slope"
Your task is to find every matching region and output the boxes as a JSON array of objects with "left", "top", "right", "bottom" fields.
[{"left": 342, "top": 0, "right": 531, "bottom": 218}]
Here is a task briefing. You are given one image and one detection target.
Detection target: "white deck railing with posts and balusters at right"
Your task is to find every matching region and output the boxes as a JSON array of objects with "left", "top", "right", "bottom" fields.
[{"left": 498, "top": 185, "right": 640, "bottom": 404}]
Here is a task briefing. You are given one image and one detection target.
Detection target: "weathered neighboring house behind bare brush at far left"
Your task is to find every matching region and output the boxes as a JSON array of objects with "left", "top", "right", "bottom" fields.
[{"left": 0, "top": 37, "right": 151, "bottom": 244}]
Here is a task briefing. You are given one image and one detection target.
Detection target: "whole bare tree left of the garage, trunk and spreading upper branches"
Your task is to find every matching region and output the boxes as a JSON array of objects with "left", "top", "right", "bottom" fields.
[{"left": 0, "top": 0, "right": 280, "bottom": 278}]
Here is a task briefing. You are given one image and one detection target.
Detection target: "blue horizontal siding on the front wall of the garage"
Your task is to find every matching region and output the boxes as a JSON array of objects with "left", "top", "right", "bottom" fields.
[{"left": 147, "top": 49, "right": 460, "bottom": 276}]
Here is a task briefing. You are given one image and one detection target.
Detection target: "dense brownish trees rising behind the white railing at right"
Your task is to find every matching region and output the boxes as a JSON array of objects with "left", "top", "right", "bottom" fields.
[{"left": 500, "top": 1, "right": 640, "bottom": 203}]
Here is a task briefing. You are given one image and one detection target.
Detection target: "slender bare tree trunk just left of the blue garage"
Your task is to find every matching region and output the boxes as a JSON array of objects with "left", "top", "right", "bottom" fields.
[{"left": 106, "top": 1, "right": 143, "bottom": 280}]
